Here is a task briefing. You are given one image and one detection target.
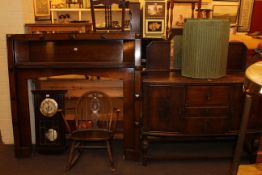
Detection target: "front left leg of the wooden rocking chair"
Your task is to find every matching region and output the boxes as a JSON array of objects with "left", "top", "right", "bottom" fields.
[{"left": 66, "top": 141, "right": 80, "bottom": 170}]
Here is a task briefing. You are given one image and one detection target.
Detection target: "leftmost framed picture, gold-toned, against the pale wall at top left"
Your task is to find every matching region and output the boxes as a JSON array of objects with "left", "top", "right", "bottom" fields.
[{"left": 34, "top": 0, "right": 50, "bottom": 17}]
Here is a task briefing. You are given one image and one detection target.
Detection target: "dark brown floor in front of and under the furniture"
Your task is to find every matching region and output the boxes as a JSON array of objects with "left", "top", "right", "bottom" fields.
[{"left": 0, "top": 141, "right": 262, "bottom": 175}]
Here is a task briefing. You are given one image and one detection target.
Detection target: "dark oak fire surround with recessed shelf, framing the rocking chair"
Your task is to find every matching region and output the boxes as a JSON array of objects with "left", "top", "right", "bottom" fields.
[{"left": 7, "top": 33, "right": 140, "bottom": 159}]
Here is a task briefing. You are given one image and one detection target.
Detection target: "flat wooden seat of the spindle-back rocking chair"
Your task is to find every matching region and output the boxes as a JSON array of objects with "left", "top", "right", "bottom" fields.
[{"left": 69, "top": 129, "right": 112, "bottom": 141}]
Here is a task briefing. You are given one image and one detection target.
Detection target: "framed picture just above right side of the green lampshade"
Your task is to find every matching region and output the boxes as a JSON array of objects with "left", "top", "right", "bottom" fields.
[{"left": 212, "top": 5, "right": 239, "bottom": 24}]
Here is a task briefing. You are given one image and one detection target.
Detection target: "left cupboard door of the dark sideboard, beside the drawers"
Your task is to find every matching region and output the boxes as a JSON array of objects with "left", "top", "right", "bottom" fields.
[{"left": 143, "top": 84, "right": 185, "bottom": 132}]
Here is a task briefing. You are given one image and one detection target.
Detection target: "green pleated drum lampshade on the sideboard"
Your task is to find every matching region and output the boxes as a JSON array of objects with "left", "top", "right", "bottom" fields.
[{"left": 181, "top": 19, "right": 230, "bottom": 78}]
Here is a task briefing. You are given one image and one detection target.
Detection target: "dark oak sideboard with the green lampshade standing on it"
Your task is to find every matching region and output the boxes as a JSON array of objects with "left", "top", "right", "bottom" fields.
[{"left": 141, "top": 41, "right": 262, "bottom": 171}]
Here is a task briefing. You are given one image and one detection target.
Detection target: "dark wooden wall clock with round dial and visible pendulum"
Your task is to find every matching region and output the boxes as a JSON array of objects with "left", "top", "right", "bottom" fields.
[{"left": 32, "top": 90, "right": 66, "bottom": 153}]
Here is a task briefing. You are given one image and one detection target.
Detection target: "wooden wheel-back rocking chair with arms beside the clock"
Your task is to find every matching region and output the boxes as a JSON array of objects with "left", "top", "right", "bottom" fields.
[{"left": 64, "top": 90, "right": 120, "bottom": 171}]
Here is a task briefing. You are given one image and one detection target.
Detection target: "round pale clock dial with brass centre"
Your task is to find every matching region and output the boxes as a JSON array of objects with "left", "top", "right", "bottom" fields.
[{"left": 40, "top": 98, "right": 58, "bottom": 117}]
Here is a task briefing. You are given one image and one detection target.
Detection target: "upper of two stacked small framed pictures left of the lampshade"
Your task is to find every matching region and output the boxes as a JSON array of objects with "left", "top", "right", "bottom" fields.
[{"left": 145, "top": 1, "right": 165, "bottom": 18}]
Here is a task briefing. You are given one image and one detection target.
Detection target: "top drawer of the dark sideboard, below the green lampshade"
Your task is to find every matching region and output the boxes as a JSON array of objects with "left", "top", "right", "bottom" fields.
[{"left": 186, "top": 86, "right": 231, "bottom": 106}]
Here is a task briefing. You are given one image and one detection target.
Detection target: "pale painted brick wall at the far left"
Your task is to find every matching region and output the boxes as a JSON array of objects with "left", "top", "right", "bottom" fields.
[{"left": 0, "top": 0, "right": 34, "bottom": 144}]
